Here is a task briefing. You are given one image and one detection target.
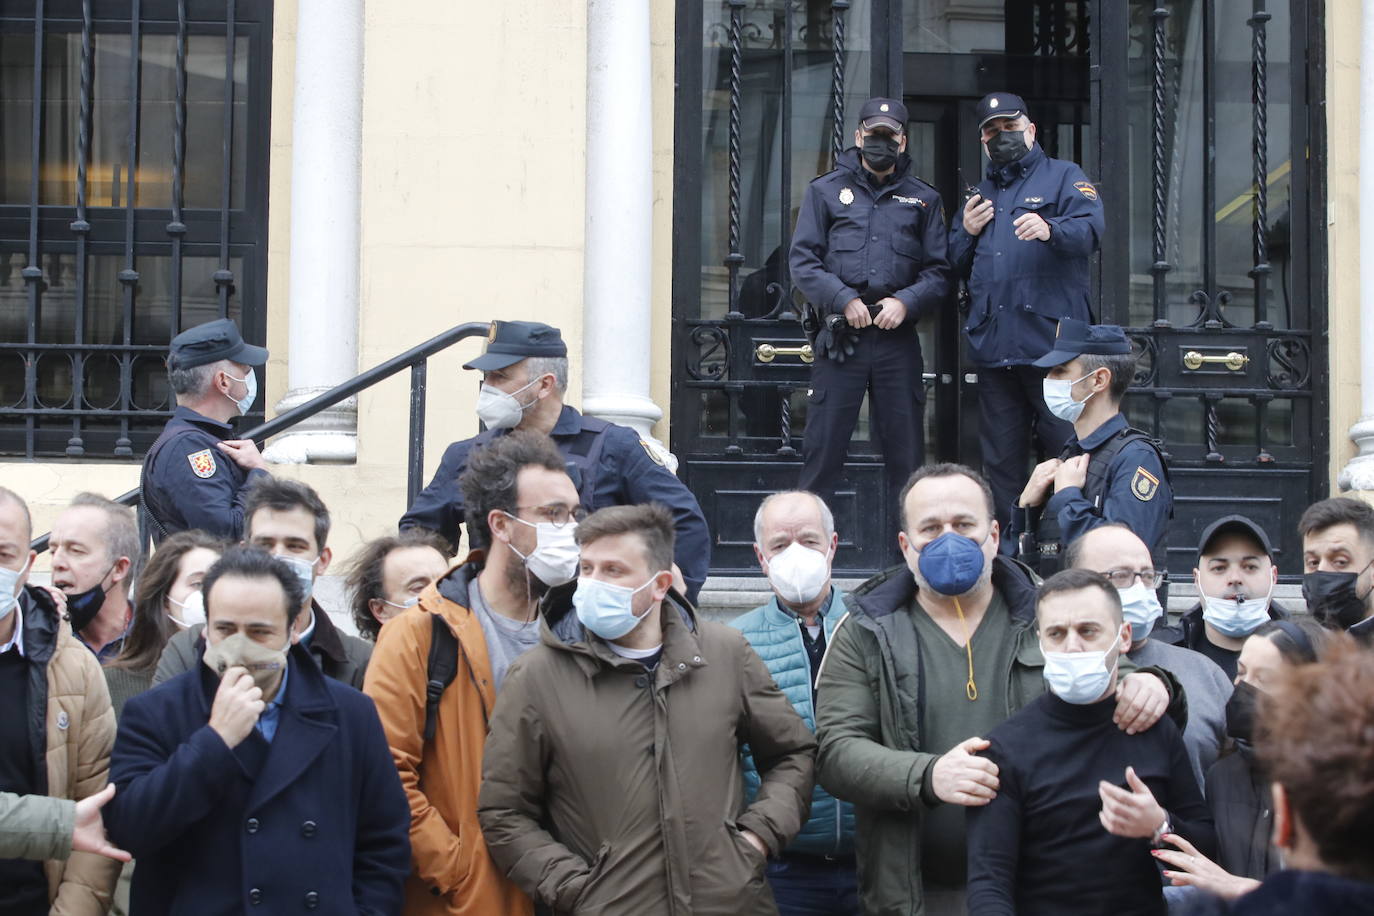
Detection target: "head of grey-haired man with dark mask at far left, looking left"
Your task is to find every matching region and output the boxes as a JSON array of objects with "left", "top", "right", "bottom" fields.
[{"left": 48, "top": 493, "right": 140, "bottom": 665}]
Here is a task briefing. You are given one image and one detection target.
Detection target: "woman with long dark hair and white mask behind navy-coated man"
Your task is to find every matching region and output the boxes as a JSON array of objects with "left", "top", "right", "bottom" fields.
[{"left": 104, "top": 529, "right": 225, "bottom": 717}]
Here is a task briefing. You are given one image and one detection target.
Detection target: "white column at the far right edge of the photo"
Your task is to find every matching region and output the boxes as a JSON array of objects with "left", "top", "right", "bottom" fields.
[{"left": 1337, "top": 3, "right": 1374, "bottom": 492}]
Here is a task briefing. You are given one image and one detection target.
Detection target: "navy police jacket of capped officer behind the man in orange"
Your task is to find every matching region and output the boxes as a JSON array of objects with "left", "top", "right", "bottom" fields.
[{"left": 400, "top": 405, "right": 710, "bottom": 599}]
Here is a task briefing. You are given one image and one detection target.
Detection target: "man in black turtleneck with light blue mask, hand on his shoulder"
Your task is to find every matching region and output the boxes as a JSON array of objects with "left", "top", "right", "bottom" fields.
[{"left": 969, "top": 570, "right": 1216, "bottom": 916}]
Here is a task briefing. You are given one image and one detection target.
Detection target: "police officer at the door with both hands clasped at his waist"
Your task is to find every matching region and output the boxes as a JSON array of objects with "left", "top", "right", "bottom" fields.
[{"left": 789, "top": 99, "right": 949, "bottom": 521}]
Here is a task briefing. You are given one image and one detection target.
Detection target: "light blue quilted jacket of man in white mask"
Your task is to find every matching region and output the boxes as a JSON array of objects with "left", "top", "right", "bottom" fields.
[{"left": 730, "top": 589, "right": 855, "bottom": 856}]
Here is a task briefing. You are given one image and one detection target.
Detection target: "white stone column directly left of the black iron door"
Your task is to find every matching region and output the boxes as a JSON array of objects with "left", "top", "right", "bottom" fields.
[{"left": 581, "top": 0, "right": 666, "bottom": 466}]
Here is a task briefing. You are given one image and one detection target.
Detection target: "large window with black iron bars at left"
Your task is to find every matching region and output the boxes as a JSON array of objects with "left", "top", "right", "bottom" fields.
[{"left": 0, "top": 0, "right": 272, "bottom": 459}]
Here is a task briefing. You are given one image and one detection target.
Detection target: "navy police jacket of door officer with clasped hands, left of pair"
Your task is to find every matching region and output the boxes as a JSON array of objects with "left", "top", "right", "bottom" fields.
[{"left": 789, "top": 147, "right": 949, "bottom": 323}]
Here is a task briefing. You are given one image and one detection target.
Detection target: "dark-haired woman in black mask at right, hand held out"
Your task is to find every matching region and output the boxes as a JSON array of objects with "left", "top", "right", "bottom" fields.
[{"left": 1156, "top": 618, "right": 1327, "bottom": 900}]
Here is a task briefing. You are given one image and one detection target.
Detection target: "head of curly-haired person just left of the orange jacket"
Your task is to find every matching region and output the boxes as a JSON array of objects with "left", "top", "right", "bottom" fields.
[{"left": 345, "top": 527, "right": 448, "bottom": 643}]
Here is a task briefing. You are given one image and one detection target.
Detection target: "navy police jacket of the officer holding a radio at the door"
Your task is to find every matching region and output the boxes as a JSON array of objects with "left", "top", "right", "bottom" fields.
[{"left": 949, "top": 144, "right": 1103, "bottom": 367}]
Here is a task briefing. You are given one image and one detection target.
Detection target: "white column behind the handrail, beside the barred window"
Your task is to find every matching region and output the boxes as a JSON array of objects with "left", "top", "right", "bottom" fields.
[{"left": 267, "top": 0, "right": 364, "bottom": 463}]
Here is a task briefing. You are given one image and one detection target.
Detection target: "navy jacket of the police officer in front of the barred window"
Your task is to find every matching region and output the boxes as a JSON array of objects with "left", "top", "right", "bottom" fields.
[{"left": 143, "top": 407, "right": 271, "bottom": 544}]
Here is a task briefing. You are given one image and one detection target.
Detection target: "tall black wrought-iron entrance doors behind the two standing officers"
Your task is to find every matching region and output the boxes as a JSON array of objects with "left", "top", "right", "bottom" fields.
[{"left": 672, "top": 0, "right": 1327, "bottom": 574}]
